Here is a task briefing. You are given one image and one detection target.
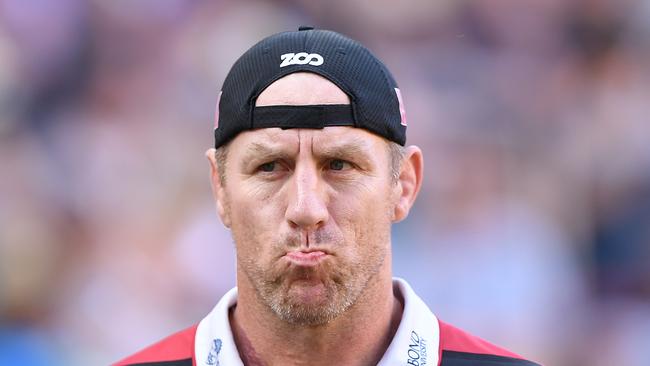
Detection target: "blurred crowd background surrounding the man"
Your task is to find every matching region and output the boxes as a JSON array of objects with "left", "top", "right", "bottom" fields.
[{"left": 0, "top": 0, "right": 650, "bottom": 366}]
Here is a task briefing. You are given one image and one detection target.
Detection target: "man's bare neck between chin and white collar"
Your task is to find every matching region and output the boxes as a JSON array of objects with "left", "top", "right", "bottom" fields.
[{"left": 230, "top": 271, "right": 403, "bottom": 366}]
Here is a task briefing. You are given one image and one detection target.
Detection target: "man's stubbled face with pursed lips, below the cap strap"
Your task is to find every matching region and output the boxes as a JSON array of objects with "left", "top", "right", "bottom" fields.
[{"left": 215, "top": 73, "right": 398, "bottom": 325}]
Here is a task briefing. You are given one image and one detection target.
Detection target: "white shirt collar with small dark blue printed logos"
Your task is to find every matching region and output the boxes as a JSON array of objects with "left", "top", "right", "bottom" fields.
[{"left": 194, "top": 278, "right": 440, "bottom": 366}]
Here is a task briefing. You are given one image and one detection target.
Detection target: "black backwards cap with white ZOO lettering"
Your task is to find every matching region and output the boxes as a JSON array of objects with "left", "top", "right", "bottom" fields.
[{"left": 214, "top": 26, "right": 406, "bottom": 148}]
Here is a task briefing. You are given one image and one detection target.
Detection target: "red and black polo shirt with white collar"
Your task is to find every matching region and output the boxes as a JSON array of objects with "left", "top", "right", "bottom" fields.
[{"left": 114, "top": 278, "right": 538, "bottom": 366}]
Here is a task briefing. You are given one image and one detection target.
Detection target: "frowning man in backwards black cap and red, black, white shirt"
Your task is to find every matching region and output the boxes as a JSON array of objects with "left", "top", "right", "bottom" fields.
[{"left": 118, "top": 27, "right": 534, "bottom": 366}]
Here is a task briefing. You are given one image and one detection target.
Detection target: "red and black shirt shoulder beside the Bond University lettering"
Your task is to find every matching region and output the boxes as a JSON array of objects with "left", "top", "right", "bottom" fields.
[{"left": 438, "top": 321, "right": 539, "bottom": 366}]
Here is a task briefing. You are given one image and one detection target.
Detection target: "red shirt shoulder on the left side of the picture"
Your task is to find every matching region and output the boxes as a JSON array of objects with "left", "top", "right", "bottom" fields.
[{"left": 113, "top": 324, "right": 198, "bottom": 366}]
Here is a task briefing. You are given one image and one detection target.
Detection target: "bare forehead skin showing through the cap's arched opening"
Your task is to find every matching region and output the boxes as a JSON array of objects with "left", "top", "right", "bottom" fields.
[{"left": 255, "top": 72, "right": 350, "bottom": 107}]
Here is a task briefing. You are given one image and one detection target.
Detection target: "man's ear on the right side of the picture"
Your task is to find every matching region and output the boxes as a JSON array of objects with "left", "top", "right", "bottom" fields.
[{"left": 393, "top": 146, "right": 424, "bottom": 222}]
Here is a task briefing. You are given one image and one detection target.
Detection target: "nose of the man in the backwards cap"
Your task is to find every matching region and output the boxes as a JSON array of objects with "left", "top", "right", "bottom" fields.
[{"left": 285, "top": 162, "right": 329, "bottom": 231}]
